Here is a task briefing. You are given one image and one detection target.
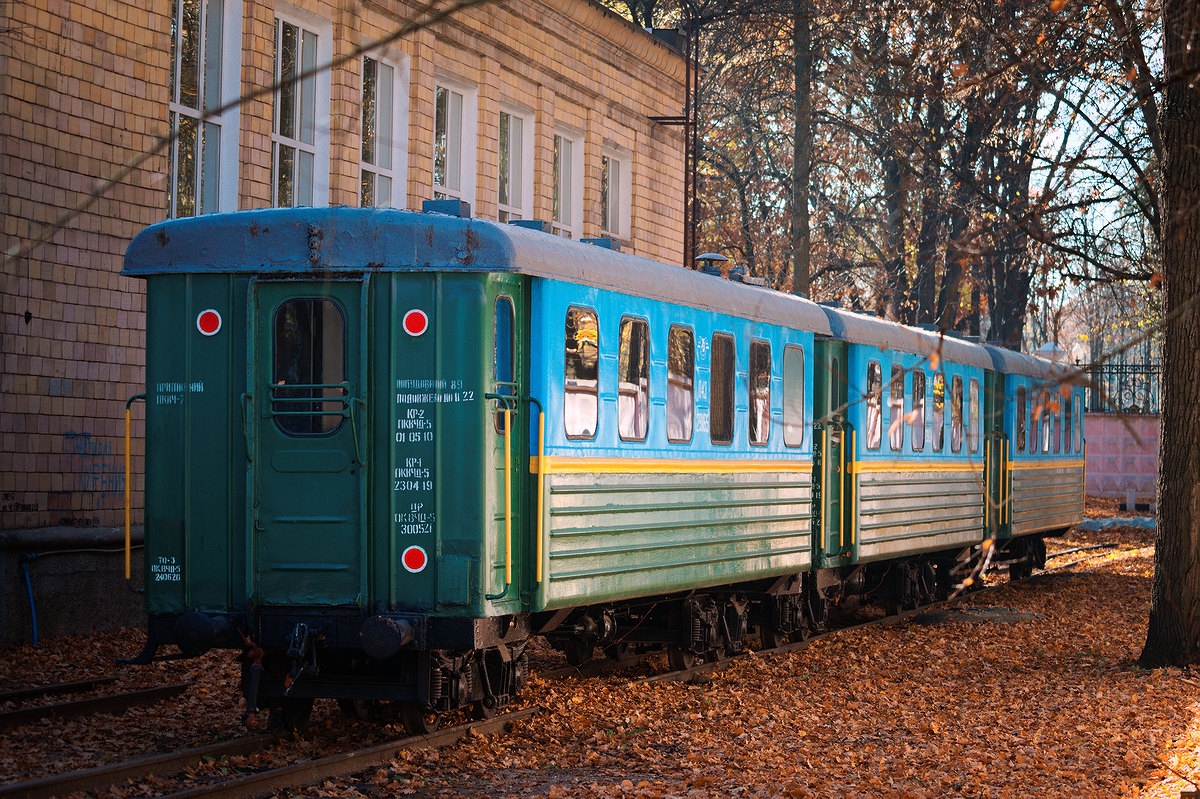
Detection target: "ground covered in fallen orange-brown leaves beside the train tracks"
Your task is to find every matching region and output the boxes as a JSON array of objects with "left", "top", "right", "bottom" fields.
[{"left": 0, "top": 501, "right": 1200, "bottom": 799}]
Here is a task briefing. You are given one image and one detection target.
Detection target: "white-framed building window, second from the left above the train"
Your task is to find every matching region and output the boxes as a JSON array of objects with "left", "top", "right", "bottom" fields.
[{"left": 271, "top": 2, "right": 334, "bottom": 206}]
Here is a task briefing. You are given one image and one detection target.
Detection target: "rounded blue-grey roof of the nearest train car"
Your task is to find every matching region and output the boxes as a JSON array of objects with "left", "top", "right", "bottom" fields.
[{"left": 121, "top": 208, "right": 830, "bottom": 335}]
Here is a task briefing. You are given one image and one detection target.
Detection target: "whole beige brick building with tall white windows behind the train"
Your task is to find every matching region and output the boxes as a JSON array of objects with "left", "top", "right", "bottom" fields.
[{"left": 0, "top": 0, "right": 685, "bottom": 644}]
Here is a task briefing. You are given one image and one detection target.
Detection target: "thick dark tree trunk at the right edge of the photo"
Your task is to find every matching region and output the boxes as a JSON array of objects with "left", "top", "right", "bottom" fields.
[{"left": 1138, "top": 0, "right": 1200, "bottom": 668}]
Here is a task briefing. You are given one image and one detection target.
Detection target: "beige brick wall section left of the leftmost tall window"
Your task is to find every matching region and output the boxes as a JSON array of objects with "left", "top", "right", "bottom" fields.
[{"left": 0, "top": 0, "right": 170, "bottom": 529}]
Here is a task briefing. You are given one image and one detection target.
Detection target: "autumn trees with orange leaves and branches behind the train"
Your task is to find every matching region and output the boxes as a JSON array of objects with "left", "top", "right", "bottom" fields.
[{"left": 604, "top": 0, "right": 1159, "bottom": 347}]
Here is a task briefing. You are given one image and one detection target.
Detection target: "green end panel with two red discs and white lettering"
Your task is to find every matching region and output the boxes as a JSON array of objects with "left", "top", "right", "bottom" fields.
[{"left": 376, "top": 272, "right": 529, "bottom": 615}]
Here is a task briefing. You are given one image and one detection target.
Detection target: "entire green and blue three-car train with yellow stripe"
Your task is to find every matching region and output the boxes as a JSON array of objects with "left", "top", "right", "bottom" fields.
[{"left": 124, "top": 203, "right": 1084, "bottom": 732}]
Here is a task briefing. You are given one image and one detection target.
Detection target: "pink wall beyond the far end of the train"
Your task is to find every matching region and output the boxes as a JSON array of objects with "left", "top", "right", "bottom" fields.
[{"left": 1084, "top": 414, "right": 1159, "bottom": 503}]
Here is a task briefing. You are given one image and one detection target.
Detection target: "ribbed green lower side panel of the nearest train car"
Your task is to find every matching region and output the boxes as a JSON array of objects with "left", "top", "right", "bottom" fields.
[{"left": 541, "top": 461, "right": 812, "bottom": 608}]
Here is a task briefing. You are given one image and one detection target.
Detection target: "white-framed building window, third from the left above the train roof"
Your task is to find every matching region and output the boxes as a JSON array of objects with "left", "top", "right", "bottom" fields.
[{"left": 359, "top": 49, "right": 409, "bottom": 208}]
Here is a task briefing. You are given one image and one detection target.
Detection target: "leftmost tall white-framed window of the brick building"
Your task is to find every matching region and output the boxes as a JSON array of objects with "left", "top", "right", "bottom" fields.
[{"left": 167, "top": 0, "right": 242, "bottom": 217}]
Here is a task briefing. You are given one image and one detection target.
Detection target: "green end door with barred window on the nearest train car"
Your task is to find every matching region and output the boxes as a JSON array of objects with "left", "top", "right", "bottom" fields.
[{"left": 245, "top": 281, "right": 366, "bottom": 606}]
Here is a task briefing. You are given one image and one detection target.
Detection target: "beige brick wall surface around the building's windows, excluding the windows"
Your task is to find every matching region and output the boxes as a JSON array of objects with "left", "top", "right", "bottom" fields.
[{"left": 0, "top": 0, "right": 684, "bottom": 529}]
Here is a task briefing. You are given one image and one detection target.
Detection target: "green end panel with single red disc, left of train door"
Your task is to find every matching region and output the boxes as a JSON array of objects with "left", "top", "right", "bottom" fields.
[{"left": 145, "top": 275, "right": 246, "bottom": 613}]
